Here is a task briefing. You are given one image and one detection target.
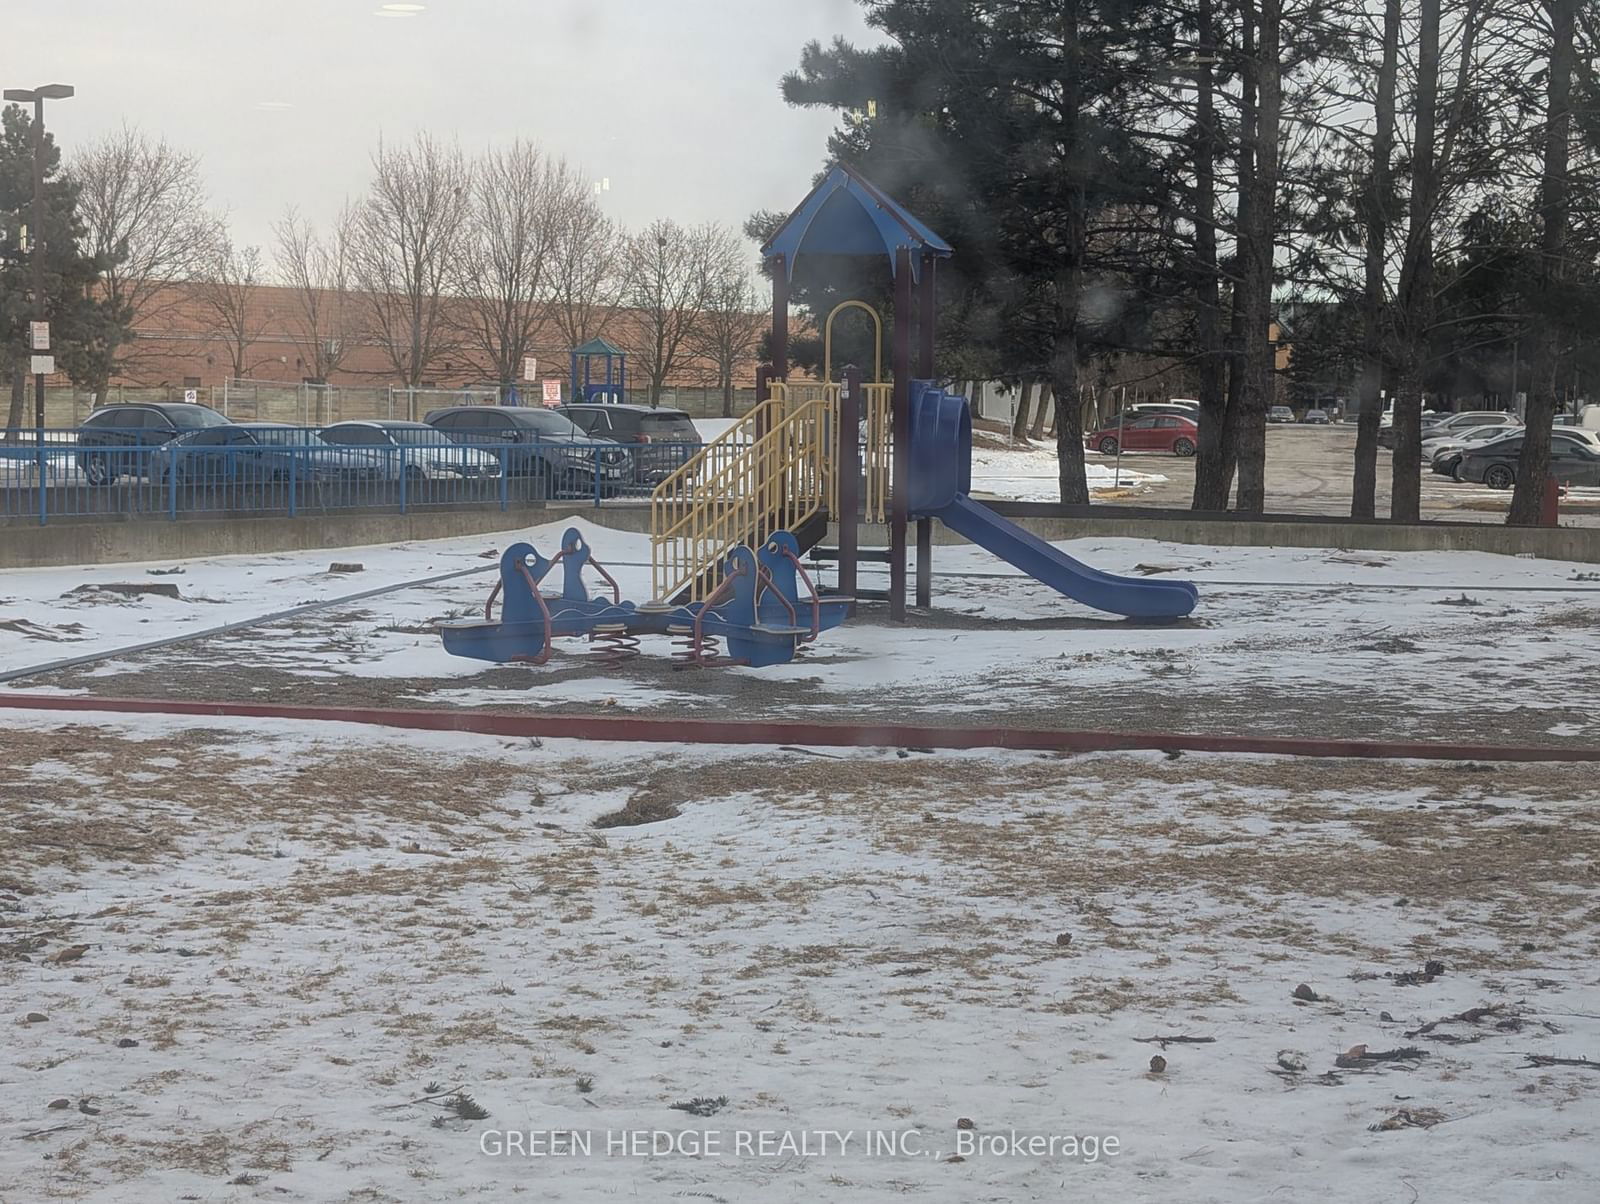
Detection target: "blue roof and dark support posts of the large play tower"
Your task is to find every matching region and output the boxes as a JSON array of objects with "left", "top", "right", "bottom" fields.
[{"left": 762, "top": 163, "right": 952, "bottom": 621}]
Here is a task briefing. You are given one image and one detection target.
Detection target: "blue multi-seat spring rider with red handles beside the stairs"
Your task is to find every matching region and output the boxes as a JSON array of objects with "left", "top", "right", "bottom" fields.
[{"left": 440, "top": 527, "right": 853, "bottom": 669}]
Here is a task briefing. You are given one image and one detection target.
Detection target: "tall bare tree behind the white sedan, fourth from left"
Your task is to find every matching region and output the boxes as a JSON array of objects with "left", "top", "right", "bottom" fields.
[{"left": 350, "top": 133, "right": 472, "bottom": 387}]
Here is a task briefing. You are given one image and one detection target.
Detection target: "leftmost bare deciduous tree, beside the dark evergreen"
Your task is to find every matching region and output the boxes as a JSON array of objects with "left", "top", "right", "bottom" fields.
[{"left": 69, "top": 125, "right": 218, "bottom": 397}]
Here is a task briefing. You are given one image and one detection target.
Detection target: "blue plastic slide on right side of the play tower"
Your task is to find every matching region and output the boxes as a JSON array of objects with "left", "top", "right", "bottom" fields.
[{"left": 910, "top": 381, "right": 1200, "bottom": 620}]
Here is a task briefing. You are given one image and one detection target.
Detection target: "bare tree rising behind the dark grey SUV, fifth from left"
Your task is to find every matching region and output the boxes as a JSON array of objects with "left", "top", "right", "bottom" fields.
[{"left": 456, "top": 139, "right": 589, "bottom": 395}]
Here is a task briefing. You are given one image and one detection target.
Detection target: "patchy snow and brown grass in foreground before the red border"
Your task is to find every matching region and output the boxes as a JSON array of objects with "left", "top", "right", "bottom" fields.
[{"left": 0, "top": 712, "right": 1600, "bottom": 1204}]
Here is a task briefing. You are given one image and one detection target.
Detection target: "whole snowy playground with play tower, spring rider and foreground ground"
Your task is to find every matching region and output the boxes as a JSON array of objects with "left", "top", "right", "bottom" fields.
[{"left": 0, "top": 170, "right": 1600, "bottom": 1204}]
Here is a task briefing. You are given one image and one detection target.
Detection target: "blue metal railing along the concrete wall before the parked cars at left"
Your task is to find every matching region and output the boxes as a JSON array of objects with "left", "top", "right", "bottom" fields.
[{"left": 0, "top": 426, "right": 699, "bottom": 524}]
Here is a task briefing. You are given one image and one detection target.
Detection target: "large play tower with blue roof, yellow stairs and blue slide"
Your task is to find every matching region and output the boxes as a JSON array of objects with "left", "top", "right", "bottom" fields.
[{"left": 651, "top": 165, "right": 1198, "bottom": 621}]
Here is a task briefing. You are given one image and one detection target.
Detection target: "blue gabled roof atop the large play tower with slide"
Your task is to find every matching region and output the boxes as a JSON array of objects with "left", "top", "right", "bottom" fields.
[{"left": 762, "top": 163, "right": 952, "bottom": 277}]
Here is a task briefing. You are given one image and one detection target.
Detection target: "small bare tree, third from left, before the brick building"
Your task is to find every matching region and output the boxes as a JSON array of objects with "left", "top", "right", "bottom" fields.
[{"left": 272, "top": 207, "right": 357, "bottom": 383}]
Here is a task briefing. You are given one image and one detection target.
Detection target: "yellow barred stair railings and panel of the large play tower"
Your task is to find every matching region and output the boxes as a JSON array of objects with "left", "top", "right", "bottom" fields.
[{"left": 650, "top": 381, "right": 893, "bottom": 600}]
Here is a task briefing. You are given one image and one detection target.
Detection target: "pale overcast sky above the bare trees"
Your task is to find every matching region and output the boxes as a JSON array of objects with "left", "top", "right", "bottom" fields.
[{"left": 12, "top": 0, "right": 874, "bottom": 259}]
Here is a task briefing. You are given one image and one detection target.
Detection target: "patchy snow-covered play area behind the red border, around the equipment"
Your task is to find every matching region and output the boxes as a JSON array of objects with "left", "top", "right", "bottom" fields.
[{"left": 12, "top": 514, "right": 1600, "bottom": 743}]
